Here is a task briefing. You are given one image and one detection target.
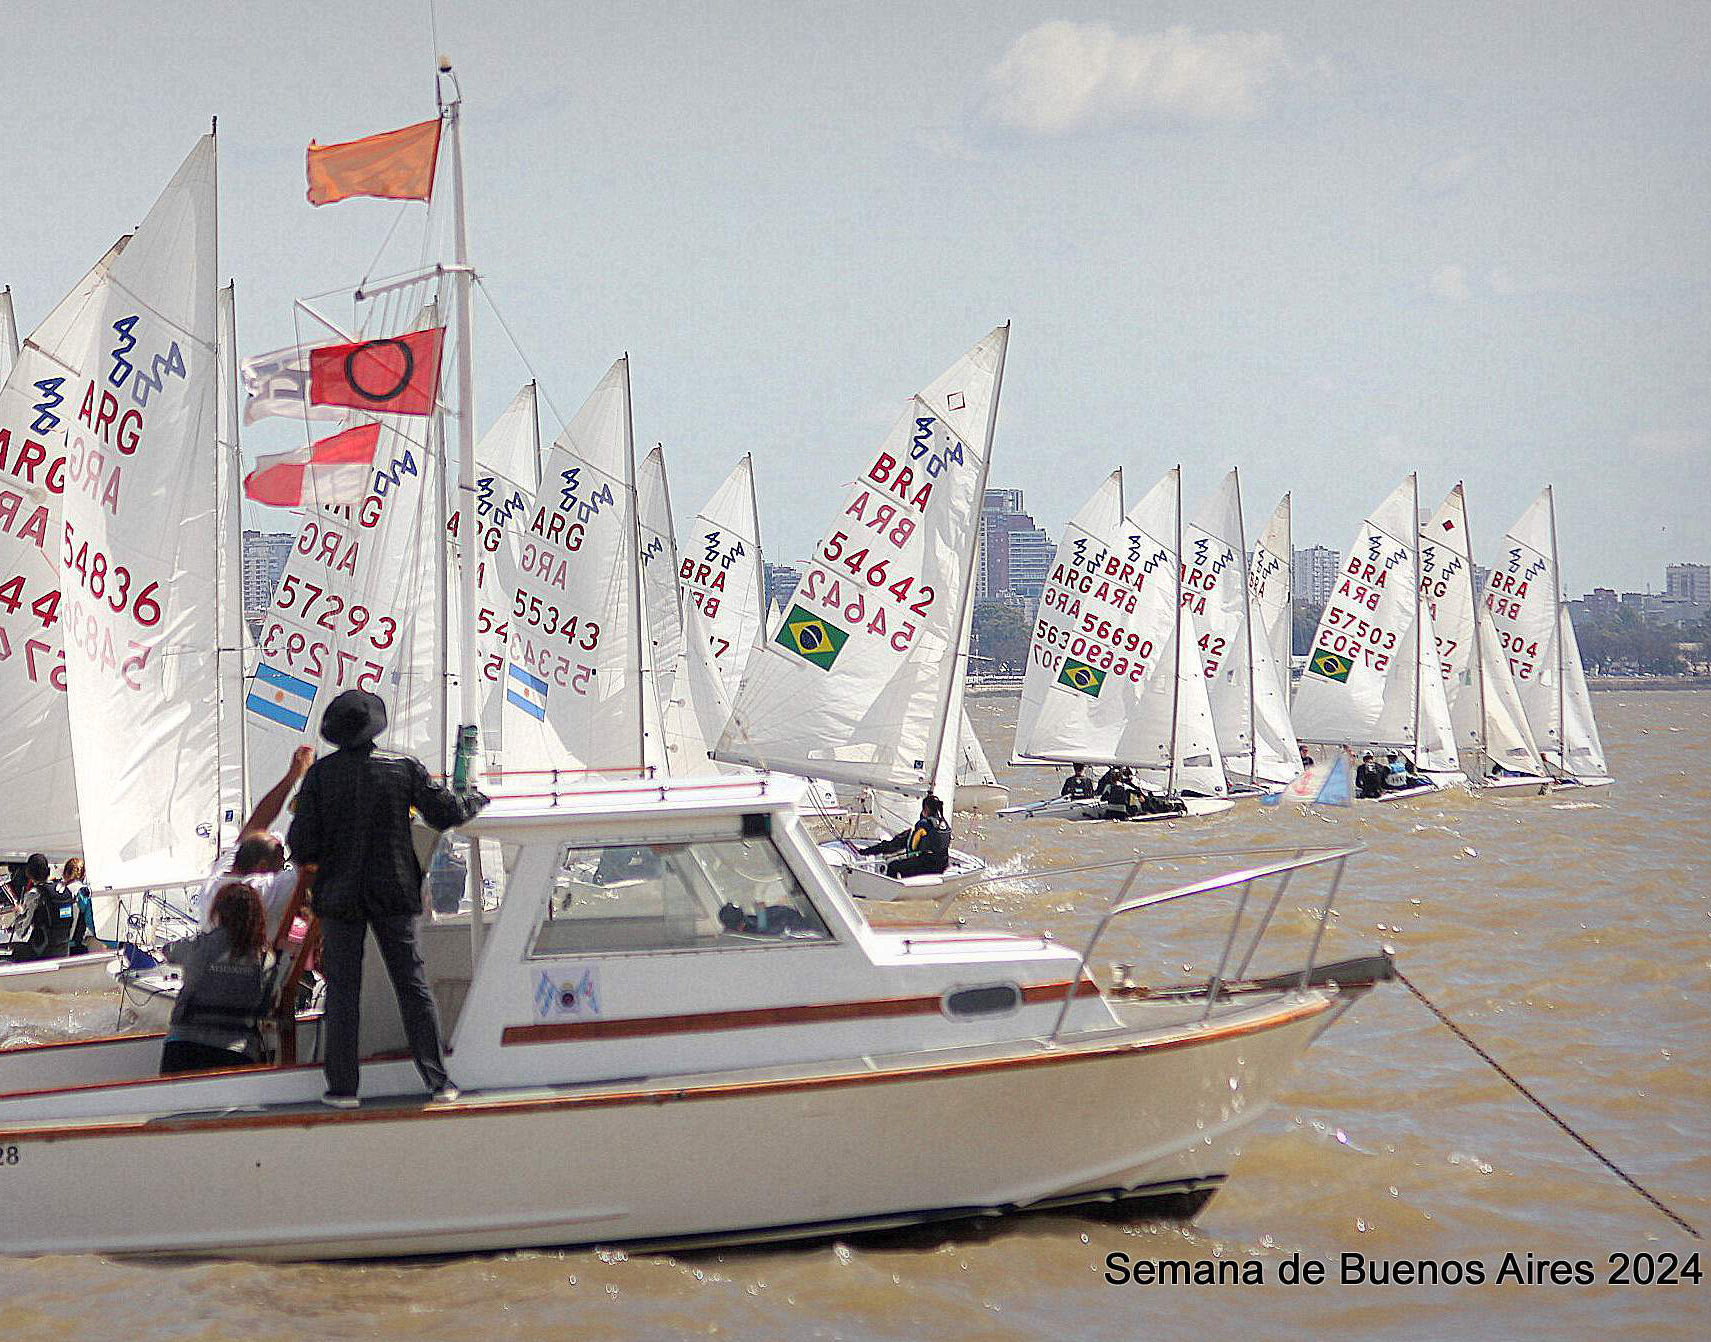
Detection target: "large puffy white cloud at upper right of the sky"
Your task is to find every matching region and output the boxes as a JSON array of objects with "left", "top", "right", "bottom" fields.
[{"left": 986, "top": 19, "right": 1328, "bottom": 135}]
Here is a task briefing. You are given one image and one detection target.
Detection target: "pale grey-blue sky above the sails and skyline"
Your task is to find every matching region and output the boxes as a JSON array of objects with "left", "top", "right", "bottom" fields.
[{"left": 0, "top": 0, "right": 1711, "bottom": 592}]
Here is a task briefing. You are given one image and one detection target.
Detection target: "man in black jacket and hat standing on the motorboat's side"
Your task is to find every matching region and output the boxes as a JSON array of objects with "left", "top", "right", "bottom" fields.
[{"left": 286, "top": 690, "right": 488, "bottom": 1109}]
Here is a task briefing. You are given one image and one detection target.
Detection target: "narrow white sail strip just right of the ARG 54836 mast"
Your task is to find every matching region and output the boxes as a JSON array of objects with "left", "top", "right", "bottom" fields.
[{"left": 212, "top": 284, "right": 250, "bottom": 847}]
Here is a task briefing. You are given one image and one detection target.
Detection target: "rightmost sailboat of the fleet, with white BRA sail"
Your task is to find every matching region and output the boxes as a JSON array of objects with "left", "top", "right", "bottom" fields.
[{"left": 1483, "top": 484, "right": 1613, "bottom": 787}]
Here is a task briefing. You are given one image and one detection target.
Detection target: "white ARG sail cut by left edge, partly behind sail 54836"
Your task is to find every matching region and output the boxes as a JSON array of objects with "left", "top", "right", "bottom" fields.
[{"left": 0, "top": 238, "right": 128, "bottom": 855}]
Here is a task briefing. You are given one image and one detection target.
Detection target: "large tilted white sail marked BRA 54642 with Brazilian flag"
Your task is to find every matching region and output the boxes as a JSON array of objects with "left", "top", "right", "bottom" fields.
[{"left": 717, "top": 327, "right": 1009, "bottom": 794}]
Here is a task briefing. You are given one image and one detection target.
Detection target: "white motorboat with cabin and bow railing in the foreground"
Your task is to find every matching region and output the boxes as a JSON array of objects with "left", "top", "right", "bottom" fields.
[{"left": 0, "top": 777, "right": 1391, "bottom": 1260}]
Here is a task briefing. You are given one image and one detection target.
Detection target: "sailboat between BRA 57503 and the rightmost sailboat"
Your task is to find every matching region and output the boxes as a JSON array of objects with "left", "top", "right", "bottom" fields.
[{"left": 1420, "top": 481, "right": 1547, "bottom": 791}]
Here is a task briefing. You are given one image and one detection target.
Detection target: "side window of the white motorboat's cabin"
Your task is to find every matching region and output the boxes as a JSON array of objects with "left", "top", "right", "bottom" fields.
[{"left": 532, "top": 837, "right": 832, "bottom": 957}]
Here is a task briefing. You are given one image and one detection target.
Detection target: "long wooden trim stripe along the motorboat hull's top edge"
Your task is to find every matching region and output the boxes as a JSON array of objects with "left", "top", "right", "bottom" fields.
[{"left": 0, "top": 996, "right": 1340, "bottom": 1143}]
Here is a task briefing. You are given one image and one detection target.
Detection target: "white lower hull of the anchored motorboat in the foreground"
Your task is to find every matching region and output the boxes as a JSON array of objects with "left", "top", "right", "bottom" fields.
[{"left": 0, "top": 991, "right": 1347, "bottom": 1260}]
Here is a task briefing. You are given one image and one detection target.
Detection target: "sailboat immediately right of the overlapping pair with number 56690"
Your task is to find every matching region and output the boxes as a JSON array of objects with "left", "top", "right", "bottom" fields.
[{"left": 1182, "top": 467, "right": 1300, "bottom": 793}]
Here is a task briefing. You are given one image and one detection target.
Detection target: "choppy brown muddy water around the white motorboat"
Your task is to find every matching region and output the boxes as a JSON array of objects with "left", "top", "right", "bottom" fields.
[{"left": 0, "top": 692, "right": 1711, "bottom": 1342}]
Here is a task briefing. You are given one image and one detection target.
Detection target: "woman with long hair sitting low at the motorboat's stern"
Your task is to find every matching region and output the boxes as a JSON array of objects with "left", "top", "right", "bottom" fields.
[{"left": 161, "top": 880, "right": 274, "bottom": 1075}]
